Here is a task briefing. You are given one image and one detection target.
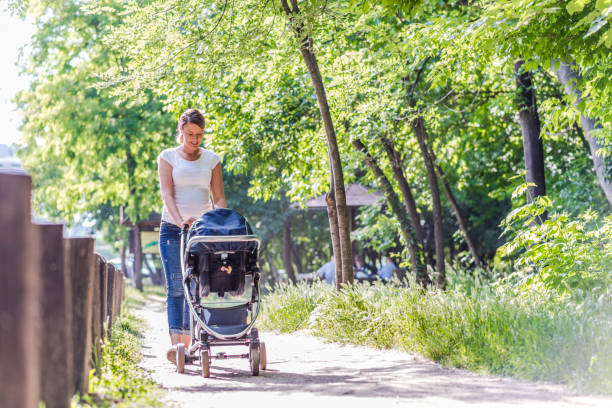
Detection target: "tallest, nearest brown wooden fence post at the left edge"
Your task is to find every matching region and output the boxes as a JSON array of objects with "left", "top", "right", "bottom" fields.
[{"left": 0, "top": 173, "right": 40, "bottom": 408}]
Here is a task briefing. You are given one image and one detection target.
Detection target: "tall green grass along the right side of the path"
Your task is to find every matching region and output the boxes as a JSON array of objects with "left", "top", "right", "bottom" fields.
[{"left": 260, "top": 278, "right": 612, "bottom": 394}]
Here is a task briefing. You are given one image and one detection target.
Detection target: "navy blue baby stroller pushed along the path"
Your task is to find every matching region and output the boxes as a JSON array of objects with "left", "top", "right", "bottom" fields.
[{"left": 176, "top": 208, "right": 266, "bottom": 378}]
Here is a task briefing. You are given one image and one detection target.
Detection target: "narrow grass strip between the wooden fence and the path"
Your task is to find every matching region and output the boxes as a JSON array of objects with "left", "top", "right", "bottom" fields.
[{"left": 72, "top": 287, "right": 162, "bottom": 407}]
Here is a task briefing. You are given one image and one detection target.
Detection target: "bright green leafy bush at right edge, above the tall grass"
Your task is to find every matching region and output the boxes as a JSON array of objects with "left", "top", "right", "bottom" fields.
[{"left": 499, "top": 188, "right": 612, "bottom": 301}]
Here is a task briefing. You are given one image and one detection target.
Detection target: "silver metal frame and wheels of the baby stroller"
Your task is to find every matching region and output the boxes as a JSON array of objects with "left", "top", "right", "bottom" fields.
[{"left": 176, "top": 226, "right": 266, "bottom": 378}]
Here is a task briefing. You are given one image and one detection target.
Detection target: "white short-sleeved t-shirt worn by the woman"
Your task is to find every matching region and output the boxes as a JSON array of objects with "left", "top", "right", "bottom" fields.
[{"left": 157, "top": 146, "right": 219, "bottom": 224}]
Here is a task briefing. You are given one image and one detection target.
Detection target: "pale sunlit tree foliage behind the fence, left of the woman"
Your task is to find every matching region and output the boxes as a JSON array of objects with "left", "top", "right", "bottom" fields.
[{"left": 16, "top": 0, "right": 175, "bottom": 231}]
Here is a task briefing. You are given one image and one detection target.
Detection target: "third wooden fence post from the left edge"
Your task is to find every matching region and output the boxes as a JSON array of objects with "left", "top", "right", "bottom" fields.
[{"left": 64, "top": 238, "right": 94, "bottom": 394}]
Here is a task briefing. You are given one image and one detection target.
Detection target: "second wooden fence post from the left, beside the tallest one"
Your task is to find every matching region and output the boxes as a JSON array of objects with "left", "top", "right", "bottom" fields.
[{"left": 37, "top": 224, "right": 73, "bottom": 408}]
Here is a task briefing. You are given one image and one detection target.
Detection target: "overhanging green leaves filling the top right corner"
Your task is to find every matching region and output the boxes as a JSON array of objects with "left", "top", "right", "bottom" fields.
[{"left": 459, "top": 0, "right": 612, "bottom": 143}]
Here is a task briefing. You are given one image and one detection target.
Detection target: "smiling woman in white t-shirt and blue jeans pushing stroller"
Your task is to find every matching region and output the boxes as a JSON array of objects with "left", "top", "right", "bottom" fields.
[{"left": 157, "top": 109, "right": 226, "bottom": 363}]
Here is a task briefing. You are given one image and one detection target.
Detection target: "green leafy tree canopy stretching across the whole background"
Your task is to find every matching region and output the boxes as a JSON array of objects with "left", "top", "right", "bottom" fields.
[{"left": 14, "top": 0, "right": 612, "bottom": 292}]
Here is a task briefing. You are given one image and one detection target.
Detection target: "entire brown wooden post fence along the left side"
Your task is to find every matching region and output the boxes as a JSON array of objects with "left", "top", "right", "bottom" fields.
[{"left": 0, "top": 173, "right": 125, "bottom": 408}]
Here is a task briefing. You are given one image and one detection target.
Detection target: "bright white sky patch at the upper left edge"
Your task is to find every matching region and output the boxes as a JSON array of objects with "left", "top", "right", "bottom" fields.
[{"left": 0, "top": 6, "right": 34, "bottom": 145}]
